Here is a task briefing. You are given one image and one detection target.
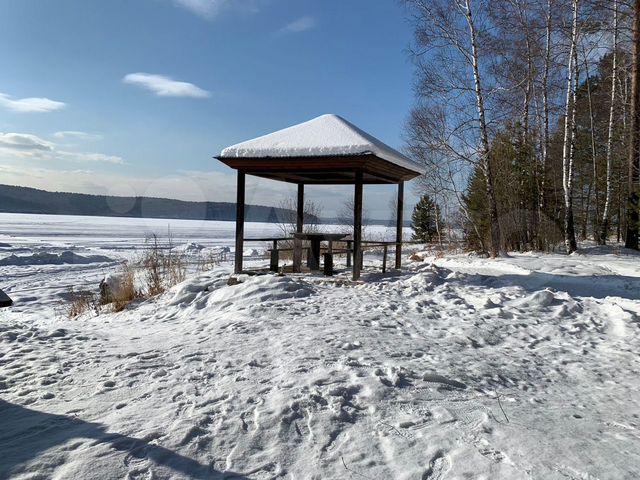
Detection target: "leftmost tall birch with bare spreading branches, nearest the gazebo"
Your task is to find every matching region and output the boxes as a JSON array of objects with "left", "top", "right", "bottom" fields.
[{"left": 406, "top": 0, "right": 501, "bottom": 256}]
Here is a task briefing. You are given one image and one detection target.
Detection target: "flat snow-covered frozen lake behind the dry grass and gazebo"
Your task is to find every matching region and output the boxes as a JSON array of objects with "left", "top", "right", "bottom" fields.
[{"left": 0, "top": 213, "right": 402, "bottom": 311}]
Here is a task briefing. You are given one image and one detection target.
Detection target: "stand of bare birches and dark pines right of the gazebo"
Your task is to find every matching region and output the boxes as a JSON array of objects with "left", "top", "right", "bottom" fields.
[{"left": 404, "top": 0, "right": 640, "bottom": 256}]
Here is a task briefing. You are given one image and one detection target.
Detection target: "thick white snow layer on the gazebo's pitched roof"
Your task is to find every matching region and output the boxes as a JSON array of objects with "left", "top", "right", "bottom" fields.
[{"left": 219, "top": 114, "right": 425, "bottom": 174}]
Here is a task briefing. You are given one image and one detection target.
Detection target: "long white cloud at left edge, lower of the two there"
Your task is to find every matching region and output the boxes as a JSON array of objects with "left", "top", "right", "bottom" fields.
[{"left": 0, "top": 132, "right": 127, "bottom": 165}]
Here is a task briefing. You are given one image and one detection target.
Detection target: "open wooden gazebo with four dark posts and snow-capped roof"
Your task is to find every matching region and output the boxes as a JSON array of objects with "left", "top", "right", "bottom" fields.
[{"left": 215, "top": 115, "right": 425, "bottom": 280}]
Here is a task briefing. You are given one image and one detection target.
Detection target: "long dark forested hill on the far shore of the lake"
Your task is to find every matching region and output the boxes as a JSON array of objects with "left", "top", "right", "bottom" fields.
[{"left": 0, "top": 185, "right": 304, "bottom": 223}]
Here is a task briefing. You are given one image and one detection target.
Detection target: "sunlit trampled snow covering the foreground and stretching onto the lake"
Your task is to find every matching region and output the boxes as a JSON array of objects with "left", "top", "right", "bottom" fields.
[{"left": 0, "top": 216, "right": 640, "bottom": 480}]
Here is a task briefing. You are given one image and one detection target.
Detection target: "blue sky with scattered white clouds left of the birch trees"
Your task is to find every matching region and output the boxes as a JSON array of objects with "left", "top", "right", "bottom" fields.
[{"left": 0, "top": 0, "right": 413, "bottom": 217}]
